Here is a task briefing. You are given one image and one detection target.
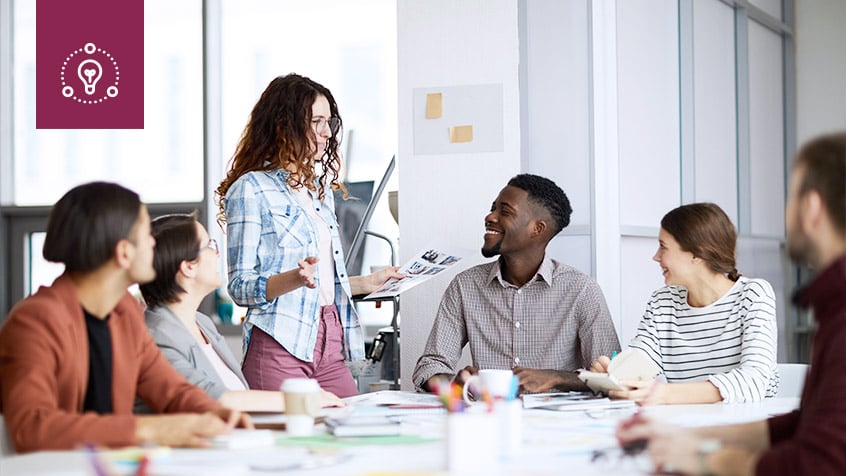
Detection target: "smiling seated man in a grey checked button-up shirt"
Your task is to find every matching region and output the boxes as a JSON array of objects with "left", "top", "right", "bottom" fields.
[{"left": 413, "top": 174, "right": 620, "bottom": 392}]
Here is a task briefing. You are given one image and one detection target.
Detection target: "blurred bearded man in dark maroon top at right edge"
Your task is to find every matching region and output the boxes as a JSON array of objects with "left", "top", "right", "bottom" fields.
[{"left": 617, "top": 132, "right": 846, "bottom": 476}]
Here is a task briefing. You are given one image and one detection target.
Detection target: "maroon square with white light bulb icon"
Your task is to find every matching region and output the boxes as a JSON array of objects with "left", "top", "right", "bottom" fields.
[{"left": 35, "top": 0, "right": 144, "bottom": 129}]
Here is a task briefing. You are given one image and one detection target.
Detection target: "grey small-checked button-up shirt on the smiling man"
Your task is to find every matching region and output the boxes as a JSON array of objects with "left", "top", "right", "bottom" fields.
[{"left": 413, "top": 256, "right": 620, "bottom": 389}]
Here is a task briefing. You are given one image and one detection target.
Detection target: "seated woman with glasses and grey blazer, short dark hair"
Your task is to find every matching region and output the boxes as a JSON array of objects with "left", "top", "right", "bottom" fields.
[{"left": 140, "top": 215, "right": 343, "bottom": 412}]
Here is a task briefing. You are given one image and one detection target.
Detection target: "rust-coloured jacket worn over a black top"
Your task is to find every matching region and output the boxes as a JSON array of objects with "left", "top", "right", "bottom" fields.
[{"left": 0, "top": 274, "right": 220, "bottom": 452}]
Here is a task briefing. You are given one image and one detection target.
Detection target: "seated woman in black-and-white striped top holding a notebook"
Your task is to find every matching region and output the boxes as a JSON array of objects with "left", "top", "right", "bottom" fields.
[{"left": 591, "top": 203, "right": 779, "bottom": 404}]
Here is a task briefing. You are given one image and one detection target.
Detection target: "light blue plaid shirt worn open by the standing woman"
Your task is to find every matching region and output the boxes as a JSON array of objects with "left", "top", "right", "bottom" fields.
[{"left": 224, "top": 169, "right": 364, "bottom": 362}]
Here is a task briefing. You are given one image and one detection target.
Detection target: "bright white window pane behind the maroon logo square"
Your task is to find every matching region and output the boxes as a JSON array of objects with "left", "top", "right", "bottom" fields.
[{"left": 12, "top": 0, "right": 203, "bottom": 205}]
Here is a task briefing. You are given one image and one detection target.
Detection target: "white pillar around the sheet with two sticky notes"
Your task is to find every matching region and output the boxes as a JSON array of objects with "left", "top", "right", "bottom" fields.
[{"left": 397, "top": 0, "right": 520, "bottom": 389}]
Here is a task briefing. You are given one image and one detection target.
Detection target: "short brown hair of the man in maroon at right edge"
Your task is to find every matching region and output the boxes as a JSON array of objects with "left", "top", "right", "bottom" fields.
[{"left": 795, "top": 132, "right": 846, "bottom": 236}]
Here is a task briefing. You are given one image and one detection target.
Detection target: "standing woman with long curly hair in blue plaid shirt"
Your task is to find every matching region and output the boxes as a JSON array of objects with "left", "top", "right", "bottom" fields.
[{"left": 216, "top": 74, "right": 402, "bottom": 397}]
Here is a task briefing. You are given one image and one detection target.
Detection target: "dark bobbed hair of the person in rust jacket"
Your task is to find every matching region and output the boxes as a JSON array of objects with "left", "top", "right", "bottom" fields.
[{"left": 43, "top": 182, "right": 141, "bottom": 272}]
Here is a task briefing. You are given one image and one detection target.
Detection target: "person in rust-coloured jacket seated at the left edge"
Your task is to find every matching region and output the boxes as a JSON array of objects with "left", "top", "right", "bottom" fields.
[{"left": 0, "top": 183, "right": 252, "bottom": 452}]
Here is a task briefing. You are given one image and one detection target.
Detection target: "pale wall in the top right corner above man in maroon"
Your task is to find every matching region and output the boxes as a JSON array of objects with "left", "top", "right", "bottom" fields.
[{"left": 795, "top": 0, "right": 846, "bottom": 144}]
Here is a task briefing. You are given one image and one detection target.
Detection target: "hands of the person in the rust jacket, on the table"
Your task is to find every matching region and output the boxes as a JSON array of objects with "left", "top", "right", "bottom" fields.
[{"left": 135, "top": 408, "right": 253, "bottom": 448}]
